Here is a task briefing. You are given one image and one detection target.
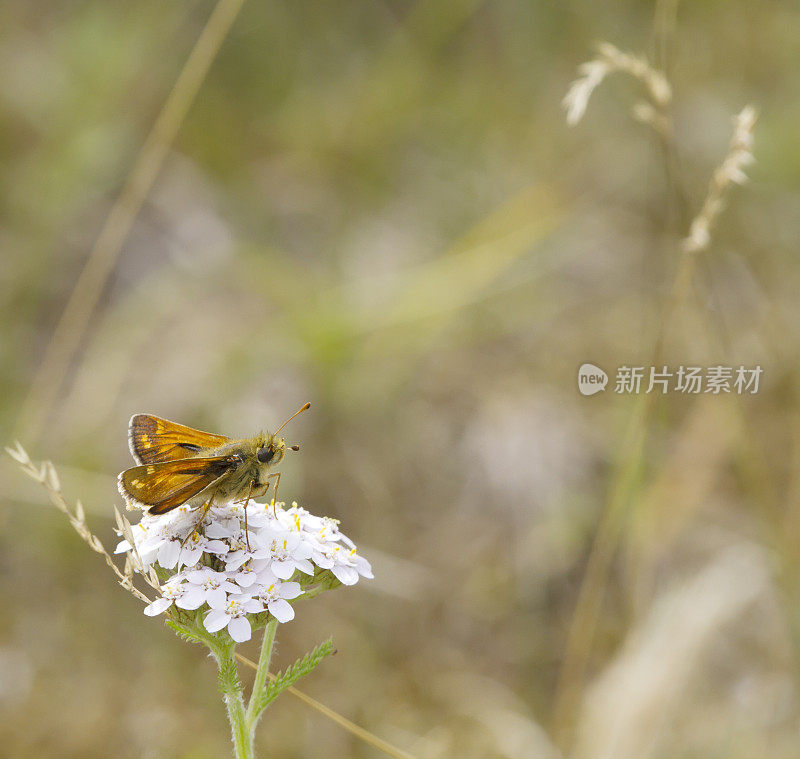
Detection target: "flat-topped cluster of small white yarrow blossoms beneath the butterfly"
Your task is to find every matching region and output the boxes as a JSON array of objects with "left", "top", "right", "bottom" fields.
[{"left": 115, "top": 501, "right": 373, "bottom": 642}]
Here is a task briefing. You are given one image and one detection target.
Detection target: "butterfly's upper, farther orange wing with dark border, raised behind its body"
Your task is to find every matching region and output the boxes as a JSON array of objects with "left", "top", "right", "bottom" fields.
[{"left": 128, "top": 414, "right": 229, "bottom": 464}]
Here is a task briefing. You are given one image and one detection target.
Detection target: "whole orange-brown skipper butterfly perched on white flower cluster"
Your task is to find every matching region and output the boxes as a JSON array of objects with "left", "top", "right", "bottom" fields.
[{"left": 117, "top": 403, "right": 311, "bottom": 519}]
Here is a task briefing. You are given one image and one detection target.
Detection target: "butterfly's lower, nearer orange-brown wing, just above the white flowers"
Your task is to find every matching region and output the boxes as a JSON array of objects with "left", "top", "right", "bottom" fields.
[{"left": 117, "top": 456, "right": 239, "bottom": 514}]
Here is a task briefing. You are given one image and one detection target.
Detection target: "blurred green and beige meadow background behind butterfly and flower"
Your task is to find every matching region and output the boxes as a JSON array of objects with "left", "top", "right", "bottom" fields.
[{"left": 0, "top": 0, "right": 800, "bottom": 759}]
